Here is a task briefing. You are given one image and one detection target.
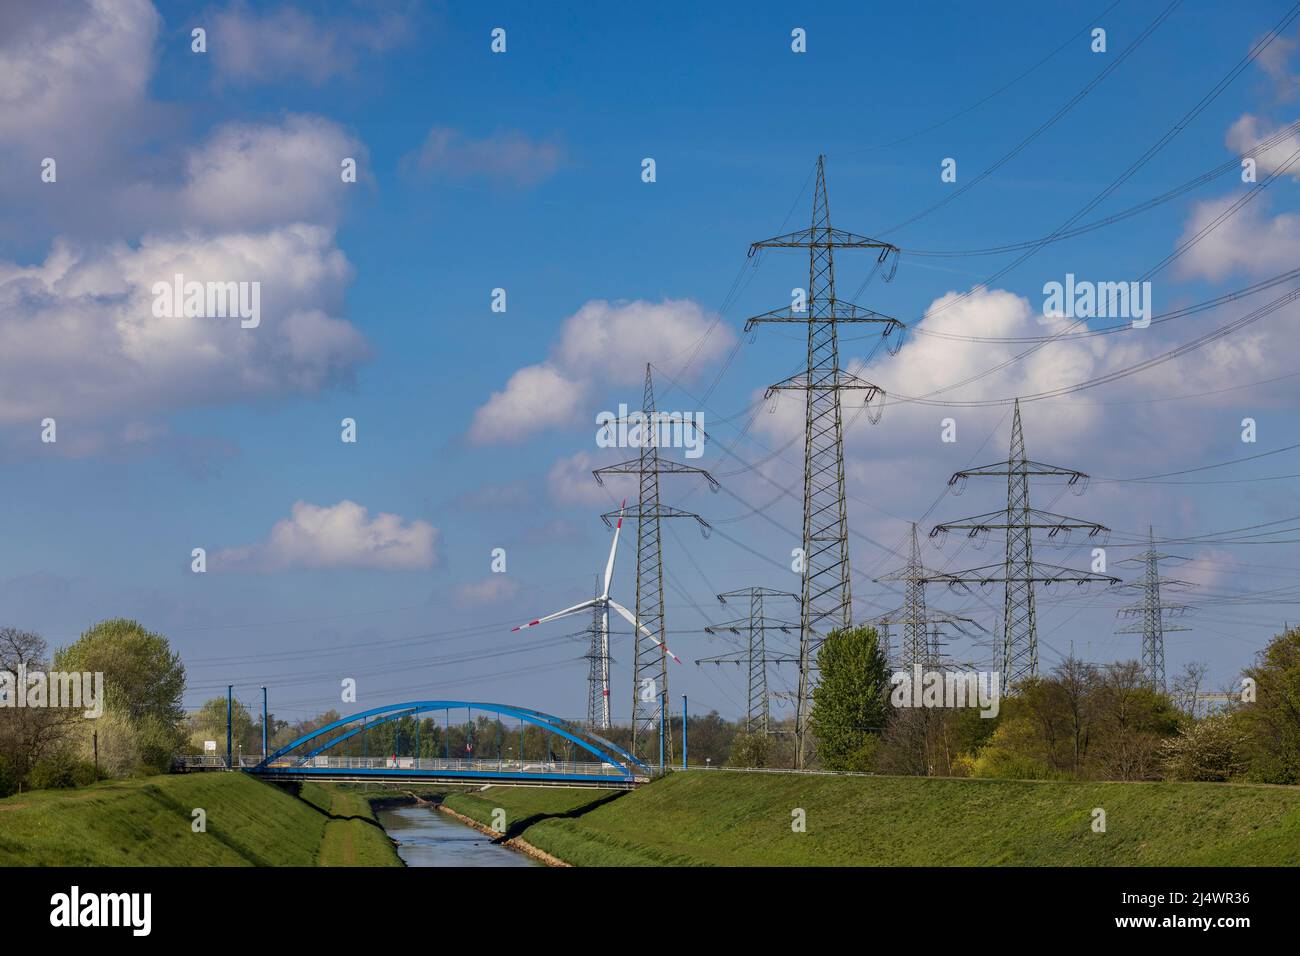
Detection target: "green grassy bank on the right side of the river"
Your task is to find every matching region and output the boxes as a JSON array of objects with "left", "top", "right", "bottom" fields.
[{"left": 446, "top": 770, "right": 1300, "bottom": 866}]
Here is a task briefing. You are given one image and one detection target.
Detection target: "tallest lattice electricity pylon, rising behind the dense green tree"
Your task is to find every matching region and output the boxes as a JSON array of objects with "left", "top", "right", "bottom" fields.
[{"left": 745, "top": 156, "right": 904, "bottom": 769}]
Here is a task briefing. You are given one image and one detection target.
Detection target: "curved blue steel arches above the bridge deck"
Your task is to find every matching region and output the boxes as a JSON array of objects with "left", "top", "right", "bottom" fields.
[{"left": 254, "top": 700, "right": 651, "bottom": 779}]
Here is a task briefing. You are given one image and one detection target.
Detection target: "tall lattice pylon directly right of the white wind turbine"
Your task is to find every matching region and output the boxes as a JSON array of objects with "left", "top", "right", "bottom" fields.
[{"left": 592, "top": 363, "right": 718, "bottom": 763}]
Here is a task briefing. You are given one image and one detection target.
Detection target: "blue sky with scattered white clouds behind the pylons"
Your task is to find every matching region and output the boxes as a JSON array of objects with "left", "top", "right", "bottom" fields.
[{"left": 0, "top": 0, "right": 1300, "bottom": 718}]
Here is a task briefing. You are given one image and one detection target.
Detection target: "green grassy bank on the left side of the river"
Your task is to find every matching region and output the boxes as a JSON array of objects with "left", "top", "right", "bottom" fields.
[{"left": 0, "top": 773, "right": 400, "bottom": 866}]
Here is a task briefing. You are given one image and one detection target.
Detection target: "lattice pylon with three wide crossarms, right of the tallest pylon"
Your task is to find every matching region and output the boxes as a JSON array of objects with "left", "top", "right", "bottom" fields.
[{"left": 926, "top": 399, "right": 1119, "bottom": 689}]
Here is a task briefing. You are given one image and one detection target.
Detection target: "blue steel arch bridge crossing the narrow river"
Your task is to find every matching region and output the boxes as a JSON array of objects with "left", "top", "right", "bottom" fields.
[{"left": 177, "top": 700, "right": 655, "bottom": 788}]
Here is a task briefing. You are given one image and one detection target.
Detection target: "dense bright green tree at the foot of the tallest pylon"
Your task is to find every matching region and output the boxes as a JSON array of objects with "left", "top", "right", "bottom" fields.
[{"left": 809, "top": 627, "right": 889, "bottom": 770}]
